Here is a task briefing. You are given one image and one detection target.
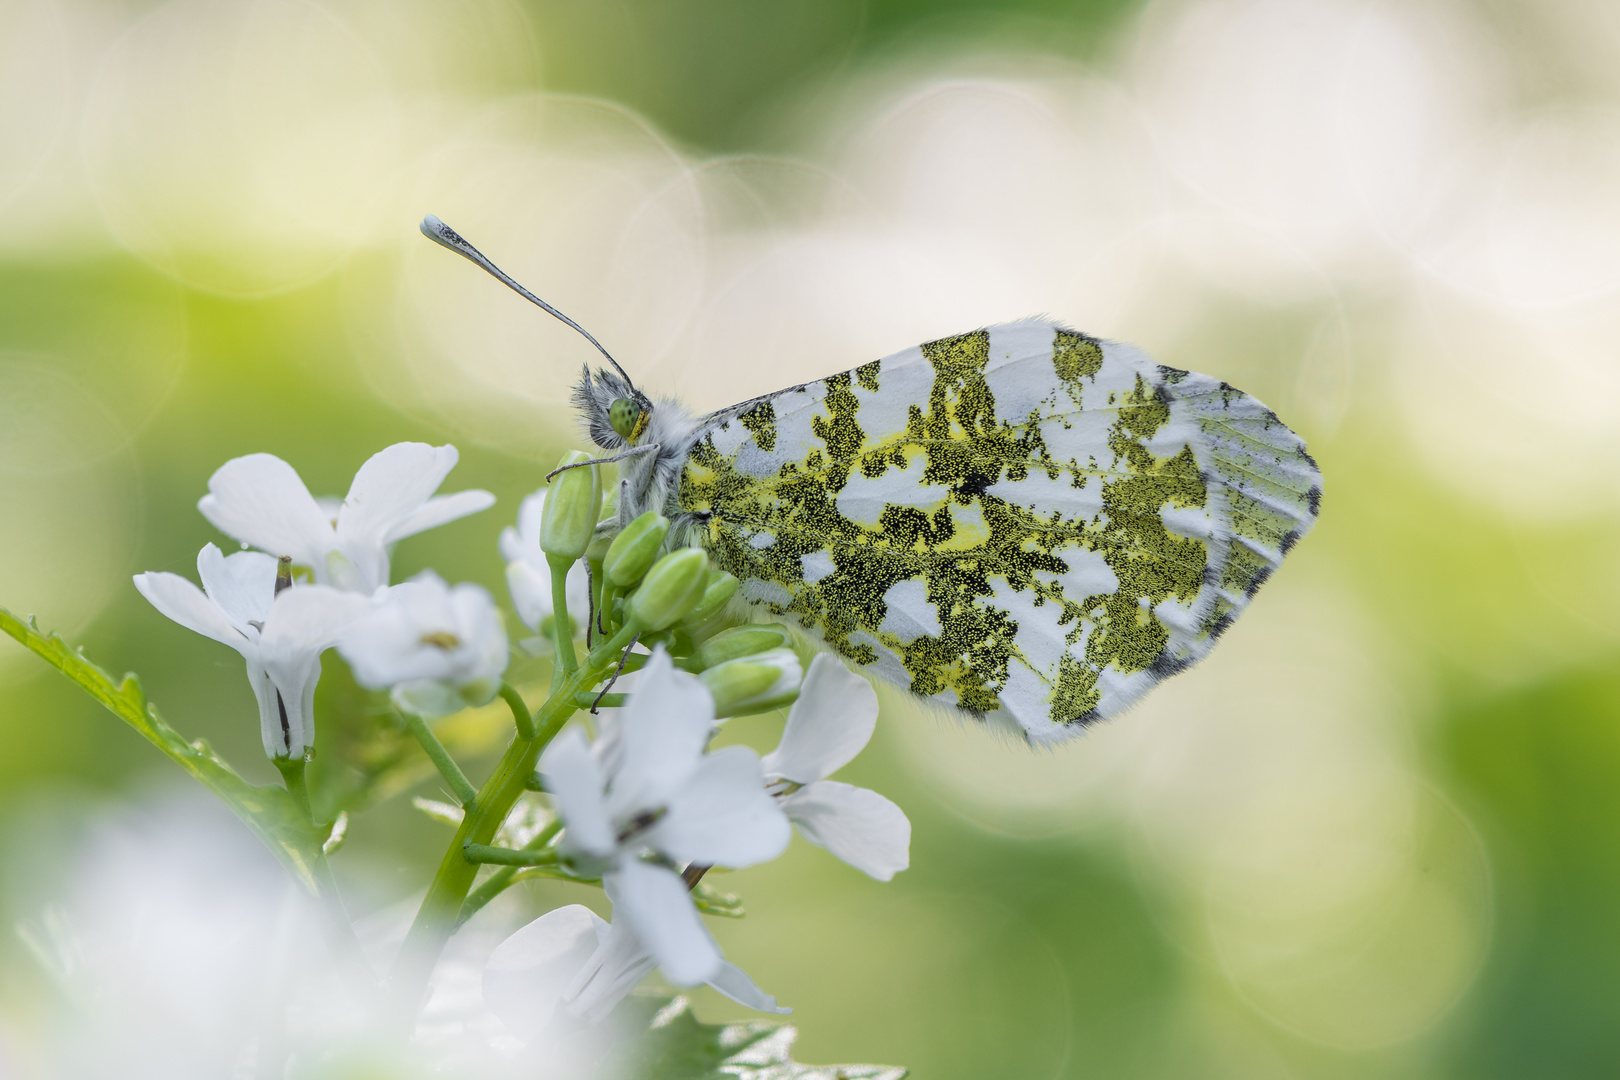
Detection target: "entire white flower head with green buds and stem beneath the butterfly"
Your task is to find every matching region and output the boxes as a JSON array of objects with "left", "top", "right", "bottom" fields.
[{"left": 134, "top": 444, "right": 910, "bottom": 1040}]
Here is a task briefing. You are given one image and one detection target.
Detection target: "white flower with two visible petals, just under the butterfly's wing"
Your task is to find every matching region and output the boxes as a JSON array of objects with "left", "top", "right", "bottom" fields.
[{"left": 760, "top": 653, "right": 910, "bottom": 881}]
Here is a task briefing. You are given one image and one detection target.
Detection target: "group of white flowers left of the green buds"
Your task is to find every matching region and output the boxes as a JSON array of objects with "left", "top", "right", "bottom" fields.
[{"left": 134, "top": 442, "right": 507, "bottom": 761}]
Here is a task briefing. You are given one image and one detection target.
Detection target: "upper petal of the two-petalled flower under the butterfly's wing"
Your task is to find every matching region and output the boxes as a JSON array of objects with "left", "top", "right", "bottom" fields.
[{"left": 765, "top": 653, "right": 878, "bottom": 784}]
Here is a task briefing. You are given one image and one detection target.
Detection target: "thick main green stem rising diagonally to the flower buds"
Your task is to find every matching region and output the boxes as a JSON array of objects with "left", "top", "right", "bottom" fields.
[{"left": 387, "top": 625, "right": 640, "bottom": 1031}]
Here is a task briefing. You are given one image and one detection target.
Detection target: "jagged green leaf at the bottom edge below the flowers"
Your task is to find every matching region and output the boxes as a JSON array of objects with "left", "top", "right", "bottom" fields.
[{"left": 599, "top": 997, "right": 907, "bottom": 1080}]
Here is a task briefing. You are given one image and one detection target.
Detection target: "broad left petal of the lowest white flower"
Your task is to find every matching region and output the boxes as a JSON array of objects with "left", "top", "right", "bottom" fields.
[{"left": 484, "top": 904, "right": 606, "bottom": 1043}]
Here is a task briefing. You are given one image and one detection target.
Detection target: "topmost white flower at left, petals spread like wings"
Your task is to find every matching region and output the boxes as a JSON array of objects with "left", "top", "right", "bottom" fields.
[{"left": 198, "top": 442, "right": 496, "bottom": 593}]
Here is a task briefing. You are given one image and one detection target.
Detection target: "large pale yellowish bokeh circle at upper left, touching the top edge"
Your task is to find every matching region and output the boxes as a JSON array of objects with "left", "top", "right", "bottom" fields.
[{"left": 79, "top": 0, "right": 402, "bottom": 295}]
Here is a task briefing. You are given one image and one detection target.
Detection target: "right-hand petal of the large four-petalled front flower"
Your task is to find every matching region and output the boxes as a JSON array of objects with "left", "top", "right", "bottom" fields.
[{"left": 643, "top": 746, "right": 792, "bottom": 866}]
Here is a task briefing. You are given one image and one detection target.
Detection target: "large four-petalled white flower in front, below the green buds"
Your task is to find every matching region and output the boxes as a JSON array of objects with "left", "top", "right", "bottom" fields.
[{"left": 539, "top": 648, "right": 791, "bottom": 986}]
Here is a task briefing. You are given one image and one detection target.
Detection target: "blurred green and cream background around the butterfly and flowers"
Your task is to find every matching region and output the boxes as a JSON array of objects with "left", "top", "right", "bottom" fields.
[{"left": 0, "top": 0, "right": 1620, "bottom": 1080}]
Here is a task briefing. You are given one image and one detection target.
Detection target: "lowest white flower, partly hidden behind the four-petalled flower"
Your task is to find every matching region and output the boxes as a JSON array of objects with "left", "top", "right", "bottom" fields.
[{"left": 484, "top": 904, "right": 792, "bottom": 1041}]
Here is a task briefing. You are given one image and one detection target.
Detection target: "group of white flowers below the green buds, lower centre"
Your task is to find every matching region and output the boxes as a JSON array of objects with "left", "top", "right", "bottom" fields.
[{"left": 484, "top": 651, "right": 910, "bottom": 1025}]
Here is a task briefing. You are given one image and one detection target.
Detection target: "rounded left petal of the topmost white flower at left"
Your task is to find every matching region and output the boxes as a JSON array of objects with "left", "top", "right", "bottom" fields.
[{"left": 198, "top": 453, "right": 335, "bottom": 575}]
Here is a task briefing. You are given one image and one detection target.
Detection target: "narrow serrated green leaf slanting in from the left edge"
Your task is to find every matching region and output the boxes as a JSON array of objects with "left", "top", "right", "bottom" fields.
[{"left": 0, "top": 607, "right": 326, "bottom": 892}]
